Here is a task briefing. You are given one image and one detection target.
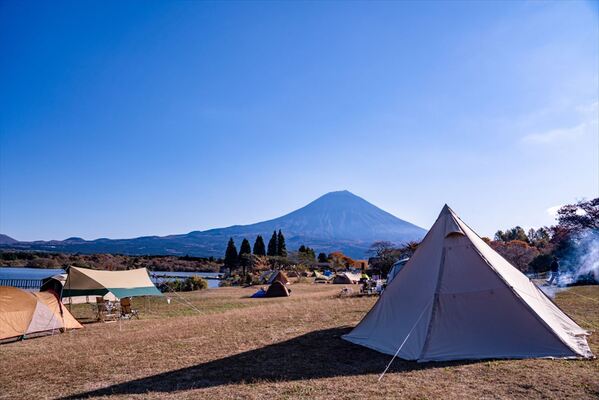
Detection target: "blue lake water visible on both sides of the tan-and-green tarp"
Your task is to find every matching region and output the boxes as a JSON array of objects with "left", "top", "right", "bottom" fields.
[{"left": 0, "top": 267, "right": 220, "bottom": 289}]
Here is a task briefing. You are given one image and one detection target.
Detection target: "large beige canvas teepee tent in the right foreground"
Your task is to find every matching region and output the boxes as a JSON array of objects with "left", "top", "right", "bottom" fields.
[{"left": 343, "top": 206, "right": 593, "bottom": 361}]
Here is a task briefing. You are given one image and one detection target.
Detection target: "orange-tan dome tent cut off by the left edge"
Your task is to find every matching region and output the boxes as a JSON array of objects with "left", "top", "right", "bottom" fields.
[{"left": 0, "top": 286, "right": 83, "bottom": 340}]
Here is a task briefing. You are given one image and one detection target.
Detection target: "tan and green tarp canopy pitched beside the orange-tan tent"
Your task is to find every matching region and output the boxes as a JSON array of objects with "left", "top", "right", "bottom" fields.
[{"left": 63, "top": 267, "right": 162, "bottom": 299}]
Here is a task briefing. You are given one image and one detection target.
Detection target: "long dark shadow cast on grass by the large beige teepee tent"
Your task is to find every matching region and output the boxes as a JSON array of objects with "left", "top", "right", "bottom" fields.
[{"left": 63, "top": 328, "right": 468, "bottom": 400}]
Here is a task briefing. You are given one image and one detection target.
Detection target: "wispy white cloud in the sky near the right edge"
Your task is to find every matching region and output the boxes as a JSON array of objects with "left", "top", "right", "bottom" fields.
[{"left": 521, "top": 101, "right": 599, "bottom": 144}]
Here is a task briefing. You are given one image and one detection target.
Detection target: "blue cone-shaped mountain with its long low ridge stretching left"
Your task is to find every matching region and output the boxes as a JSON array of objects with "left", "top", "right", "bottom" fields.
[{"left": 0, "top": 190, "right": 426, "bottom": 258}]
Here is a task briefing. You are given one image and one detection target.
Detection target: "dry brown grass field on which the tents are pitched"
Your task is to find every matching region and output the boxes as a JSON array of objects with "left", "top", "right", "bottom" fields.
[{"left": 0, "top": 284, "right": 599, "bottom": 399}]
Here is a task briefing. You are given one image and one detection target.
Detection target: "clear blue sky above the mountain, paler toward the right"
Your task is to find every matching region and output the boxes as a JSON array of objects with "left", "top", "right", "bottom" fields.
[{"left": 0, "top": 1, "right": 599, "bottom": 240}]
